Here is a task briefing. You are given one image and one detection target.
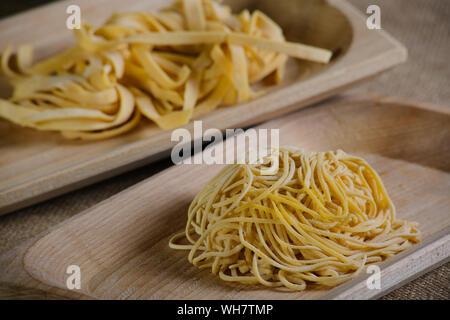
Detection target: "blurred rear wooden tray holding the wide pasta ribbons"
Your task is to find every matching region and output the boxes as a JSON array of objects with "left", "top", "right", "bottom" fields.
[{"left": 0, "top": 0, "right": 407, "bottom": 214}]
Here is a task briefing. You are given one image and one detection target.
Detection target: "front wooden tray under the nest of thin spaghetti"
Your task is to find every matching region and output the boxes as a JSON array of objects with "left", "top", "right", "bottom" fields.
[{"left": 0, "top": 97, "right": 450, "bottom": 299}]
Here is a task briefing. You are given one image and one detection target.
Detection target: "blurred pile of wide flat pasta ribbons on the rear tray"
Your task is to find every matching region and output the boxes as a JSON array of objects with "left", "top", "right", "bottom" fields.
[{"left": 0, "top": 0, "right": 331, "bottom": 139}]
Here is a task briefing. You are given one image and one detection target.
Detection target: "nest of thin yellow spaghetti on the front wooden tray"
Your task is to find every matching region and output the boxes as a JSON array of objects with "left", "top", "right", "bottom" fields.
[{"left": 169, "top": 148, "right": 420, "bottom": 290}]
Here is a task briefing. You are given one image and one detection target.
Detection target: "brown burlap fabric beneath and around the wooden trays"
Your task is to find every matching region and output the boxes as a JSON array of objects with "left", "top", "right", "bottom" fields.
[{"left": 0, "top": 0, "right": 450, "bottom": 299}]
